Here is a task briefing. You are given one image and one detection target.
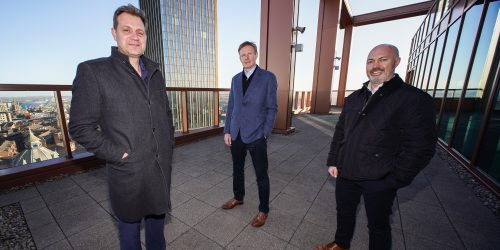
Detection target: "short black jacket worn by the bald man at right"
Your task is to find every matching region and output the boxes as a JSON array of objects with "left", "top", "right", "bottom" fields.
[{"left": 327, "top": 75, "right": 437, "bottom": 188}]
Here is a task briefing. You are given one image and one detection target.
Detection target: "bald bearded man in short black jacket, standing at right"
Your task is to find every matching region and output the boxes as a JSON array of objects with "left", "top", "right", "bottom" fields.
[{"left": 316, "top": 44, "right": 437, "bottom": 250}]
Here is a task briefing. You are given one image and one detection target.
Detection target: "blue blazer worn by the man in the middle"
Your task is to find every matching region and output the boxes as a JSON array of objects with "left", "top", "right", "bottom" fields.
[{"left": 224, "top": 66, "right": 278, "bottom": 143}]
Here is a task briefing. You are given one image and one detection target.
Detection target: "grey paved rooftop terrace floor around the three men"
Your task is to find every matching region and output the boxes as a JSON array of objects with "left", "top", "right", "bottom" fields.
[{"left": 0, "top": 115, "right": 500, "bottom": 250}]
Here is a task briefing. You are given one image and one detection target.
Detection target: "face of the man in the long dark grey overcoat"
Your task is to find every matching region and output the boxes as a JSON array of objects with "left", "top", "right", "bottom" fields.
[{"left": 111, "top": 12, "right": 146, "bottom": 57}]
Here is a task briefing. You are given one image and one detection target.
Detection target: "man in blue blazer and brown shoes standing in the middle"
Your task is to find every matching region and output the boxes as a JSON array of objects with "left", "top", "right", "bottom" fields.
[{"left": 222, "top": 41, "right": 278, "bottom": 227}]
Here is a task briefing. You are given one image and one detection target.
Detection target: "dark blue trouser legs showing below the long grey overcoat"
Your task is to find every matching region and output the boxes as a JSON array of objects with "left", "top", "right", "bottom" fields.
[{"left": 118, "top": 214, "right": 167, "bottom": 250}]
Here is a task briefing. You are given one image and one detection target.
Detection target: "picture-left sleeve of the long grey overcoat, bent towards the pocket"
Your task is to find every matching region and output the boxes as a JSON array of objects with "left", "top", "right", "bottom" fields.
[{"left": 69, "top": 63, "right": 126, "bottom": 162}]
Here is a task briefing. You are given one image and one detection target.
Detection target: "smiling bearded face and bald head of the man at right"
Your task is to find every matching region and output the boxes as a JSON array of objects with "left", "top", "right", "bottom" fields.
[{"left": 366, "top": 45, "right": 401, "bottom": 84}]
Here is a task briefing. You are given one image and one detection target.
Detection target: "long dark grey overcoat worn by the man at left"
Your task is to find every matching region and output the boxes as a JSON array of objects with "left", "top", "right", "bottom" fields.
[{"left": 69, "top": 47, "right": 174, "bottom": 221}]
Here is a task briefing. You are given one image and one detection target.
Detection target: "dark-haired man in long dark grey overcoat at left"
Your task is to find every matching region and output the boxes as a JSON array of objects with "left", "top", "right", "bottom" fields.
[{"left": 69, "top": 5, "right": 174, "bottom": 249}]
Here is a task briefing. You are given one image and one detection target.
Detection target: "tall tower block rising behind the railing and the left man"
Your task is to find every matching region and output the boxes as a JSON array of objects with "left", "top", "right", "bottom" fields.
[{"left": 139, "top": 0, "right": 217, "bottom": 130}]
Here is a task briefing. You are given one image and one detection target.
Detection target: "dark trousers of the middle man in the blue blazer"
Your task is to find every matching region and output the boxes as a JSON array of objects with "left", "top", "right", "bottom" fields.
[{"left": 231, "top": 134, "right": 269, "bottom": 214}]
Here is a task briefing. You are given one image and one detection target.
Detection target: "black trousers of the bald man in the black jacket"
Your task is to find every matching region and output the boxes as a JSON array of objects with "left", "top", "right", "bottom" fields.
[{"left": 335, "top": 178, "right": 396, "bottom": 250}]
